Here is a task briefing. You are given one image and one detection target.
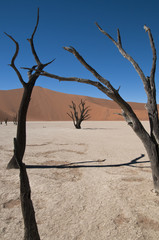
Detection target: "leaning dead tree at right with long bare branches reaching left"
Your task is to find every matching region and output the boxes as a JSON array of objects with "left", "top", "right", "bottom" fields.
[{"left": 41, "top": 23, "right": 159, "bottom": 192}]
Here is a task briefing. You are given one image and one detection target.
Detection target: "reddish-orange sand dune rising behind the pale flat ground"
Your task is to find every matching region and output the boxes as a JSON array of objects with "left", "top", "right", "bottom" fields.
[{"left": 0, "top": 87, "right": 148, "bottom": 121}]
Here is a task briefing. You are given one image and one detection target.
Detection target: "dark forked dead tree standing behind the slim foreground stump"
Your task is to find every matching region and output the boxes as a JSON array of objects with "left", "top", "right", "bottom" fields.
[{"left": 5, "top": 10, "right": 53, "bottom": 169}]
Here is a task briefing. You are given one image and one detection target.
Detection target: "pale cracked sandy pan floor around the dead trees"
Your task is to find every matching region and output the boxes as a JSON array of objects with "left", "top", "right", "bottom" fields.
[{"left": 0, "top": 122, "right": 159, "bottom": 240}]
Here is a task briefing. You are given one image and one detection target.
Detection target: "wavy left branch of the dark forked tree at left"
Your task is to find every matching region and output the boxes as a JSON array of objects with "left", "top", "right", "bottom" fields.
[{"left": 5, "top": 33, "right": 26, "bottom": 87}]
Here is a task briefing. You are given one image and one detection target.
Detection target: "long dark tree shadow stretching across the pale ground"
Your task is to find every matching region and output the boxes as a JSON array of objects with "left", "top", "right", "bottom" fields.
[{"left": 26, "top": 154, "right": 150, "bottom": 169}]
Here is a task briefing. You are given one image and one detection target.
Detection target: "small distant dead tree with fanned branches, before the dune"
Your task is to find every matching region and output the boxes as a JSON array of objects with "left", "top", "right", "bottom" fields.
[{"left": 67, "top": 99, "right": 90, "bottom": 129}]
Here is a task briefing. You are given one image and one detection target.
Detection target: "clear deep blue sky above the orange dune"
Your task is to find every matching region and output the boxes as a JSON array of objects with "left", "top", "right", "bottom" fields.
[{"left": 0, "top": 0, "right": 159, "bottom": 102}]
